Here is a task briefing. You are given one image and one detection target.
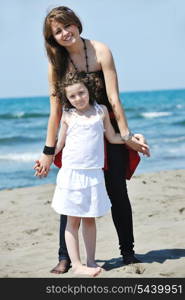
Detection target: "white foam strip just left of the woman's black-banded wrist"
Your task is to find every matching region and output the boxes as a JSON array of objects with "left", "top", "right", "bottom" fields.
[{"left": 0, "top": 152, "right": 41, "bottom": 162}]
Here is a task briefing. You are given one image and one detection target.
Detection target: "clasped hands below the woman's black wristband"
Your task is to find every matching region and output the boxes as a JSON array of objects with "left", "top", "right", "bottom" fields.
[{"left": 33, "top": 153, "right": 53, "bottom": 178}]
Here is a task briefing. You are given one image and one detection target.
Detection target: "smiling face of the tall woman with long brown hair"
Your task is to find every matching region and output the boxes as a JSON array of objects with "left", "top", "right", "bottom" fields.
[{"left": 51, "top": 21, "right": 80, "bottom": 47}]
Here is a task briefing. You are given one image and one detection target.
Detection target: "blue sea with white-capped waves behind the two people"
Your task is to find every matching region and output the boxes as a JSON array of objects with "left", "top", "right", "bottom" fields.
[{"left": 0, "top": 89, "right": 185, "bottom": 190}]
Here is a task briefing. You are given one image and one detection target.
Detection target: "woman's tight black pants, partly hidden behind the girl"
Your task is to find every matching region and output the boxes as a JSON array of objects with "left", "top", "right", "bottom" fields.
[{"left": 58, "top": 143, "right": 134, "bottom": 260}]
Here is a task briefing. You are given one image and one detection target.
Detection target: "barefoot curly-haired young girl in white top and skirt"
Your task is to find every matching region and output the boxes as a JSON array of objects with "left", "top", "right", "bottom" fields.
[{"left": 52, "top": 76, "right": 123, "bottom": 276}]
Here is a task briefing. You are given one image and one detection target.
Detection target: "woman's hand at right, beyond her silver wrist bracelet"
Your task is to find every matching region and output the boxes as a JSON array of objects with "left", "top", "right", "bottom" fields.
[{"left": 126, "top": 133, "right": 150, "bottom": 157}]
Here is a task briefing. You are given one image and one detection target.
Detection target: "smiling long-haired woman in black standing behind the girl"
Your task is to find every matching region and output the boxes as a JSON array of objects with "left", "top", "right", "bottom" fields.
[{"left": 34, "top": 6, "right": 150, "bottom": 274}]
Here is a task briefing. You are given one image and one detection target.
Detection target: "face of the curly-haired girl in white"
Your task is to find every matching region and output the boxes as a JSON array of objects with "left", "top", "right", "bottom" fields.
[{"left": 65, "top": 83, "right": 90, "bottom": 111}]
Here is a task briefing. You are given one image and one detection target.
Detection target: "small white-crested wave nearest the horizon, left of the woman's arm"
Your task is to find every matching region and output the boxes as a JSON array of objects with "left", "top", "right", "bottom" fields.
[{"left": 0, "top": 111, "right": 49, "bottom": 120}]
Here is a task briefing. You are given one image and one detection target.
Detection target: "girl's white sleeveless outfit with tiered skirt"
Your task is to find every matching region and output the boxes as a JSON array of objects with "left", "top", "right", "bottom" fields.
[{"left": 51, "top": 103, "right": 111, "bottom": 217}]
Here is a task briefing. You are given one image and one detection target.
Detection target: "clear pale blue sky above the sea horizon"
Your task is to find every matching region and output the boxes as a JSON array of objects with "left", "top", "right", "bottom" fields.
[{"left": 0, "top": 0, "right": 185, "bottom": 98}]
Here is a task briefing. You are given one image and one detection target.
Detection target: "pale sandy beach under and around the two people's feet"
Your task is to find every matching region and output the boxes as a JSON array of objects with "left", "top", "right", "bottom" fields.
[{"left": 0, "top": 170, "right": 185, "bottom": 278}]
